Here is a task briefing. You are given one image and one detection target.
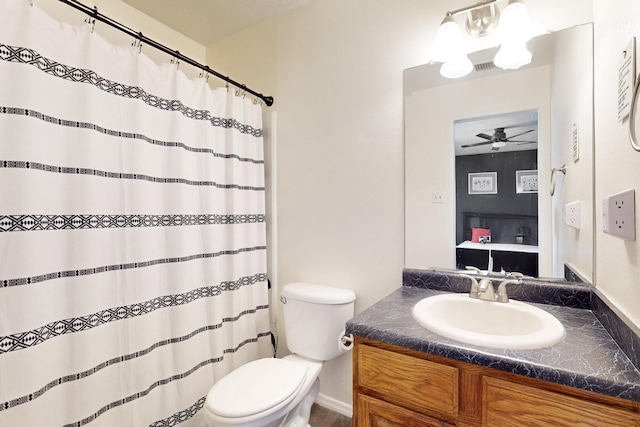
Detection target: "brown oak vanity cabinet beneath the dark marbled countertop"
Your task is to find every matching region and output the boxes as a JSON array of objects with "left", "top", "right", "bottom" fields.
[{"left": 353, "top": 337, "right": 640, "bottom": 427}]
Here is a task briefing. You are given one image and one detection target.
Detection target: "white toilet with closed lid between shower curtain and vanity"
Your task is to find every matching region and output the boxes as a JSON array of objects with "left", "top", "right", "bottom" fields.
[{"left": 203, "top": 283, "right": 356, "bottom": 427}]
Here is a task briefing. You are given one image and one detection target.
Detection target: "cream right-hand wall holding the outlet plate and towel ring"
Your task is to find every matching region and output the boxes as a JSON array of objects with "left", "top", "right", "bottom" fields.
[{"left": 594, "top": 0, "right": 640, "bottom": 326}]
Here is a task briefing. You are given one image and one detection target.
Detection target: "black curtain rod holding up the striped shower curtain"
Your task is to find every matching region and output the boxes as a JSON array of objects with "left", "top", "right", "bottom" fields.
[{"left": 58, "top": 0, "right": 273, "bottom": 107}]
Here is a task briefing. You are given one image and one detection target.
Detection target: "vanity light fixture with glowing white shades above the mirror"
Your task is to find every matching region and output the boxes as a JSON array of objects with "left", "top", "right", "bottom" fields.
[{"left": 431, "top": 0, "right": 531, "bottom": 78}]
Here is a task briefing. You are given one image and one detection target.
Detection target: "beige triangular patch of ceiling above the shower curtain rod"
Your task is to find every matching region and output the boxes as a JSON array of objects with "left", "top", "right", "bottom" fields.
[{"left": 123, "top": 0, "right": 309, "bottom": 46}]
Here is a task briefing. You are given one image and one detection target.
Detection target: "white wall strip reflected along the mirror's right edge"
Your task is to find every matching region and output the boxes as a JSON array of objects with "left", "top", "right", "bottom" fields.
[{"left": 552, "top": 25, "right": 594, "bottom": 282}]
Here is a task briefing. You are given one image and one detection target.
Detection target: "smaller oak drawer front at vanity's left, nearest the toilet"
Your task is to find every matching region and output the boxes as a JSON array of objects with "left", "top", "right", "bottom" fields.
[{"left": 356, "top": 345, "right": 459, "bottom": 416}]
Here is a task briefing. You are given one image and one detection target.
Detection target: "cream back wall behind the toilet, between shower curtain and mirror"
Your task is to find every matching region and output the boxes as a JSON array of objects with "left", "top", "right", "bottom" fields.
[{"left": 207, "top": 0, "right": 608, "bottom": 412}]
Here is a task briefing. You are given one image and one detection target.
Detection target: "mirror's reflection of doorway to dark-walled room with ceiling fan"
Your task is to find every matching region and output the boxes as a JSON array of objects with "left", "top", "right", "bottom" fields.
[{"left": 453, "top": 110, "right": 538, "bottom": 277}]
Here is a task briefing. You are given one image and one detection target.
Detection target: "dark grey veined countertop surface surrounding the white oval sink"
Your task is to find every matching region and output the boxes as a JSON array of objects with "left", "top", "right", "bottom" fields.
[{"left": 346, "top": 286, "right": 640, "bottom": 402}]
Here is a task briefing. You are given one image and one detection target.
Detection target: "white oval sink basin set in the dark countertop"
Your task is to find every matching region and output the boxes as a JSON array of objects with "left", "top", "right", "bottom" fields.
[{"left": 412, "top": 294, "right": 565, "bottom": 349}]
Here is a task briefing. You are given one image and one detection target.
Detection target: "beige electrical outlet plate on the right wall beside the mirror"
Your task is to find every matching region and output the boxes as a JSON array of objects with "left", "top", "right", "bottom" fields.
[{"left": 602, "top": 190, "right": 636, "bottom": 240}]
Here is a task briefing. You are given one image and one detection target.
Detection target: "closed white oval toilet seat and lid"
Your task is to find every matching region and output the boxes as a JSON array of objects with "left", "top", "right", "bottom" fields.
[{"left": 205, "top": 358, "right": 307, "bottom": 418}]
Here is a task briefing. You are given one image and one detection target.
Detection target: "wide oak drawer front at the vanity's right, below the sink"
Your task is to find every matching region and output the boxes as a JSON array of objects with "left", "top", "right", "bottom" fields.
[{"left": 482, "top": 377, "right": 640, "bottom": 427}]
